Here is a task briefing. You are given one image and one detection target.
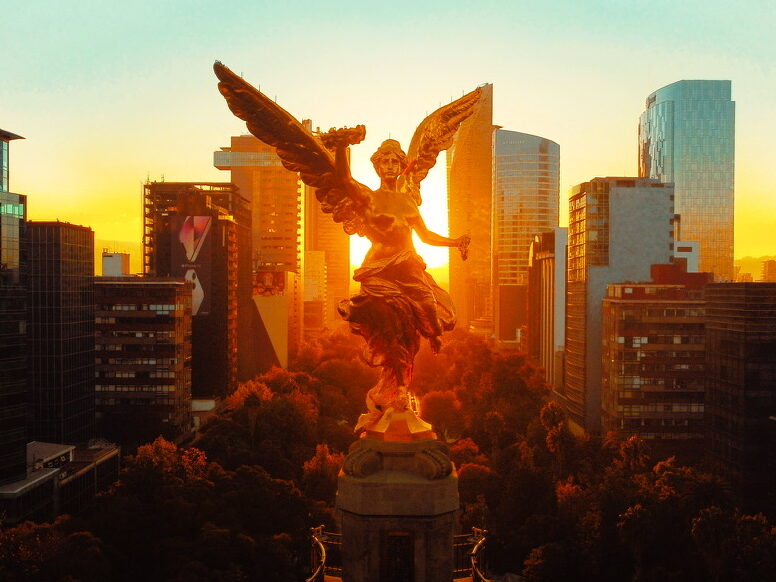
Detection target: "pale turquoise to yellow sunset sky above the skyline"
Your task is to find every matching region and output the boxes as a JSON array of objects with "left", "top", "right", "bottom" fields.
[{"left": 6, "top": 0, "right": 776, "bottom": 272}]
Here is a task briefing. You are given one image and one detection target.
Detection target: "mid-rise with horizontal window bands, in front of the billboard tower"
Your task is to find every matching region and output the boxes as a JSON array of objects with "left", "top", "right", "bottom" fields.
[{"left": 95, "top": 277, "right": 194, "bottom": 452}]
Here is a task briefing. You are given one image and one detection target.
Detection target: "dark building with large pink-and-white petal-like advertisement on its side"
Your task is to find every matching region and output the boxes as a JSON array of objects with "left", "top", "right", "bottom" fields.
[{"left": 144, "top": 182, "right": 244, "bottom": 398}]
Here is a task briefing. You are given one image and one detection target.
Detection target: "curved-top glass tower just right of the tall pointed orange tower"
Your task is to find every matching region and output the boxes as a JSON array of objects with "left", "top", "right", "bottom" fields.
[{"left": 491, "top": 129, "right": 560, "bottom": 346}]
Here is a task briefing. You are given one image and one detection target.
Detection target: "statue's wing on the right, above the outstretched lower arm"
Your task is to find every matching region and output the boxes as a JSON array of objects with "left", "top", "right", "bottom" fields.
[{"left": 402, "top": 88, "right": 482, "bottom": 204}]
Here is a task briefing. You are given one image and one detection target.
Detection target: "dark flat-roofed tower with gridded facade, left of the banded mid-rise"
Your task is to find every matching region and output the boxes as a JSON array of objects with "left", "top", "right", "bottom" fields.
[{"left": 27, "top": 222, "right": 95, "bottom": 444}]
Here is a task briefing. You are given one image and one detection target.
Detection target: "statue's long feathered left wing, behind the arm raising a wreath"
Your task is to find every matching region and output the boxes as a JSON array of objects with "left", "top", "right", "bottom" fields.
[{"left": 213, "top": 61, "right": 367, "bottom": 235}]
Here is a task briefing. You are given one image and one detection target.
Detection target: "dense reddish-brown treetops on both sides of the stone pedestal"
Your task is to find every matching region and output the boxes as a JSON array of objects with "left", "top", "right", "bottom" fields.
[{"left": 0, "top": 332, "right": 776, "bottom": 582}]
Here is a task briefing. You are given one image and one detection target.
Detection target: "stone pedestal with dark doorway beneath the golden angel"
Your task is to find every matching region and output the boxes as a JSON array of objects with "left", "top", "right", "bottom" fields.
[{"left": 337, "top": 433, "right": 459, "bottom": 582}]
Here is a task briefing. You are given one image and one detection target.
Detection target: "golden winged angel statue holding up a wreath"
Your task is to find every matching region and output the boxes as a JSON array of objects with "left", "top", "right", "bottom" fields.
[{"left": 214, "top": 62, "right": 481, "bottom": 440}]
